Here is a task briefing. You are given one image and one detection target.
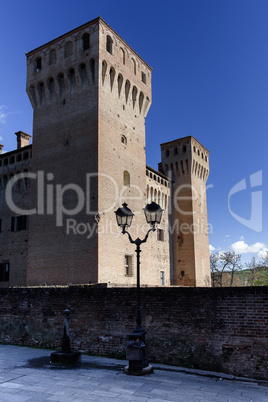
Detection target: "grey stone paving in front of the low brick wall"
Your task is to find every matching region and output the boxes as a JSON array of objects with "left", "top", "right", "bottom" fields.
[{"left": 0, "top": 345, "right": 268, "bottom": 402}]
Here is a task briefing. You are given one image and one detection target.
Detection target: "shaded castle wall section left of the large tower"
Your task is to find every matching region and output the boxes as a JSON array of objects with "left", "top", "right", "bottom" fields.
[{"left": 0, "top": 146, "right": 31, "bottom": 287}]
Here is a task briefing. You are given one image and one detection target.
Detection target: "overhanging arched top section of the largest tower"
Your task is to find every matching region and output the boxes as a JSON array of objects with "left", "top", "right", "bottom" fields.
[{"left": 26, "top": 17, "right": 152, "bottom": 116}]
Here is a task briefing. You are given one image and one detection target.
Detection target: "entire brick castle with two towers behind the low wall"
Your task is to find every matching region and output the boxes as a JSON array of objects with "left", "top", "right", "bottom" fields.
[{"left": 0, "top": 17, "right": 210, "bottom": 287}]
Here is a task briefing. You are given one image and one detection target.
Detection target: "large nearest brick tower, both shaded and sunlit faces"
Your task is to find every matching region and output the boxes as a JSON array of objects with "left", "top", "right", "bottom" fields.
[{"left": 27, "top": 17, "right": 154, "bottom": 285}]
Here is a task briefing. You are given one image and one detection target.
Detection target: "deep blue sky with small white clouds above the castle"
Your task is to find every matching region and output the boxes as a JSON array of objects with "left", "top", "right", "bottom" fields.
[{"left": 0, "top": 0, "right": 268, "bottom": 261}]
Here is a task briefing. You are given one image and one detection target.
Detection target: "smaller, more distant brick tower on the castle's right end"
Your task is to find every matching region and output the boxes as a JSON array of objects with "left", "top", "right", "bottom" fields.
[{"left": 161, "top": 136, "right": 210, "bottom": 286}]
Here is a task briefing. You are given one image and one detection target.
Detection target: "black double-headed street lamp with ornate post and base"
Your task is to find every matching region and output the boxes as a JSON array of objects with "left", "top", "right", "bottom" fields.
[{"left": 115, "top": 202, "right": 163, "bottom": 375}]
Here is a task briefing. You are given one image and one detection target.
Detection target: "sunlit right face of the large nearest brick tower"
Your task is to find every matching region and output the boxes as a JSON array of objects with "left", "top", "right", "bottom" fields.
[{"left": 96, "top": 23, "right": 159, "bottom": 285}]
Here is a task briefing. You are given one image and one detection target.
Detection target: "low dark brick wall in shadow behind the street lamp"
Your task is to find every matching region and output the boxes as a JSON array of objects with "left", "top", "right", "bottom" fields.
[{"left": 0, "top": 286, "right": 268, "bottom": 379}]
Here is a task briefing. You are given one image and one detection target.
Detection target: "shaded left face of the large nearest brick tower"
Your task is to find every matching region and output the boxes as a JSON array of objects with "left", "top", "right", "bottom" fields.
[{"left": 27, "top": 22, "right": 99, "bottom": 285}]
